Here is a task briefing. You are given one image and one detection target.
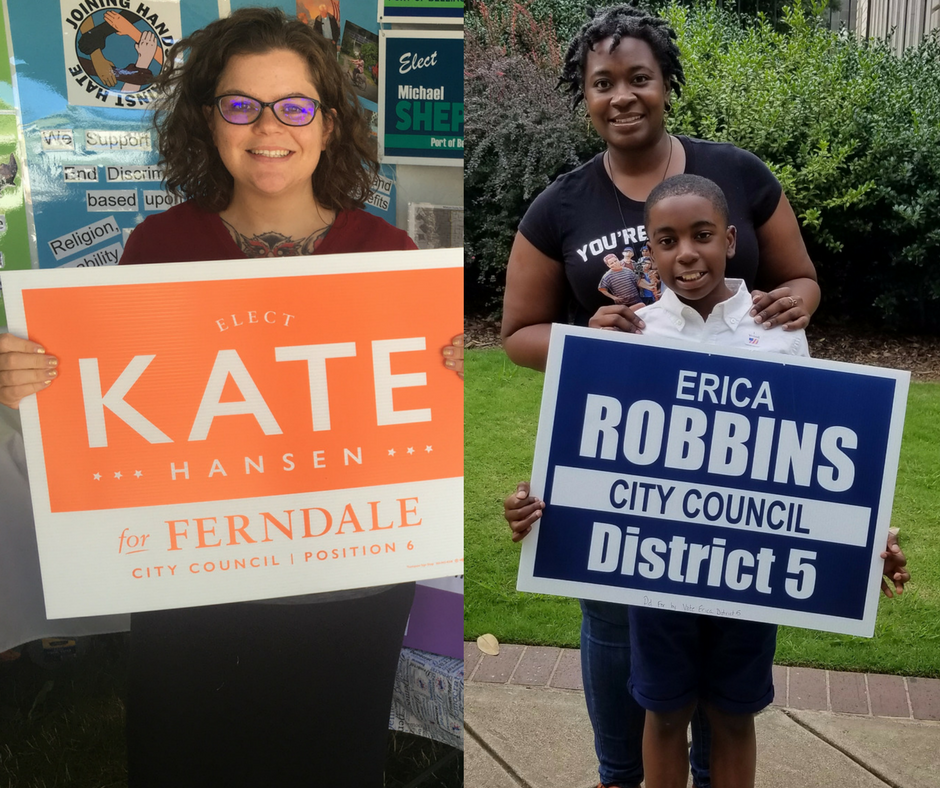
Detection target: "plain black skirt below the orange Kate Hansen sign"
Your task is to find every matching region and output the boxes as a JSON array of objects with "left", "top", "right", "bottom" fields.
[{"left": 127, "top": 583, "right": 414, "bottom": 788}]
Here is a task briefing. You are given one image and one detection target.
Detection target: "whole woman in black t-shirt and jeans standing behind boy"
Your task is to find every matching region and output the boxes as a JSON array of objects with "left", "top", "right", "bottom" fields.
[{"left": 502, "top": 6, "right": 820, "bottom": 788}]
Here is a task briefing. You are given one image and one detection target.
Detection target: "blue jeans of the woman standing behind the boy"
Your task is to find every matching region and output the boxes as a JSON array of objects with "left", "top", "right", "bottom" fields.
[{"left": 581, "top": 599, "right": 711, "bottom": 788}]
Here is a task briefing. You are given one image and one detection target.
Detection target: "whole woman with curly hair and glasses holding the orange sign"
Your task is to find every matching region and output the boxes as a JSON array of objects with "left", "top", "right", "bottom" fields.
[{"left": 0, "top": 8, "right": 416, "bottom": 788}]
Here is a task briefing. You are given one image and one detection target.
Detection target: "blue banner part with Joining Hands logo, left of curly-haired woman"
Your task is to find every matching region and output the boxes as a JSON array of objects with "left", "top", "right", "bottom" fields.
[{"left": 7, "top": 0, "right": 218, "bottom": 268}]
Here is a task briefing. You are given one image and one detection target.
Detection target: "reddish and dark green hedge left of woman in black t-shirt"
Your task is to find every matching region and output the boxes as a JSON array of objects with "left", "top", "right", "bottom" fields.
[{"left": 464, "top": 3, "right": 597, "bottom": 311}]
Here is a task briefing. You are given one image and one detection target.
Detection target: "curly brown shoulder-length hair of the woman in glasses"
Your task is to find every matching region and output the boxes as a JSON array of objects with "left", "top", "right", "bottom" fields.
[{"left": 153, "top": 8, "right": 379, "bottom": 213}]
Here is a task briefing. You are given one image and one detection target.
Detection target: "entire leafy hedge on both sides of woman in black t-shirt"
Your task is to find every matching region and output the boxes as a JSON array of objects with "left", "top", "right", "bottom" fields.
[{"left": 466, "top": 0, "right": 940, "bottom": 332}]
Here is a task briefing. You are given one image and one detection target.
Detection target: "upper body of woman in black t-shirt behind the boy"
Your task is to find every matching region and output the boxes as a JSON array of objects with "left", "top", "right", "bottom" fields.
[{"left": 502, "top": 6, "right": 819, "bottom": 369}]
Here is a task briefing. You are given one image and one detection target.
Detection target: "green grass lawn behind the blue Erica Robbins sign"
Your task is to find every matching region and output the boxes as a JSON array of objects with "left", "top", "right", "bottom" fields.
[{"left": 464, "top": 350, "right": 940, "bottom": 677}]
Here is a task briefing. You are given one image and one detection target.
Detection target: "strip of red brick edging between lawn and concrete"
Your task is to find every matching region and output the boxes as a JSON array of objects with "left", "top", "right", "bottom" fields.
[{"left": 464, "top": 643, "right": 940, "bottom": 722}]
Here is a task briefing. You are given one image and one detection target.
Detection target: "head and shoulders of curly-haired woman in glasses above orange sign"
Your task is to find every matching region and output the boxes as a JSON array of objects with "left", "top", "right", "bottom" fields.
[{"left": 121, "top": 8, "right": 404, "bottom": 264}]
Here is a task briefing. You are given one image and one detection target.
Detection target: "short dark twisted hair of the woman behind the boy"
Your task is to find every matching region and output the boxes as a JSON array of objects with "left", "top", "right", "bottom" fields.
[{"left": 558, "top": 5, "right": 685, "bottom": 106}]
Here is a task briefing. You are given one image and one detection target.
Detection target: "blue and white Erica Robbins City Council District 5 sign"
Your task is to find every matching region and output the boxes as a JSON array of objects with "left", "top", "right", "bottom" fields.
[{"left": 518, "top": 325, "right": 909, "bottom": 637}]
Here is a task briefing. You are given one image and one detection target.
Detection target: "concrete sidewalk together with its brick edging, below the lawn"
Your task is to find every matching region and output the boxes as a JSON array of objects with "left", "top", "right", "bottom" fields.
[{"left": 464, "top": 643, "right": 940, "bottom": 788}]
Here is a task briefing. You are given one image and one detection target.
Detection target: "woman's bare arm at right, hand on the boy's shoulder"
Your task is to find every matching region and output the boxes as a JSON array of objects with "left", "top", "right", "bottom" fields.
[{"left": 751, "top": 194, "right": 820, "bottom": 330}]
